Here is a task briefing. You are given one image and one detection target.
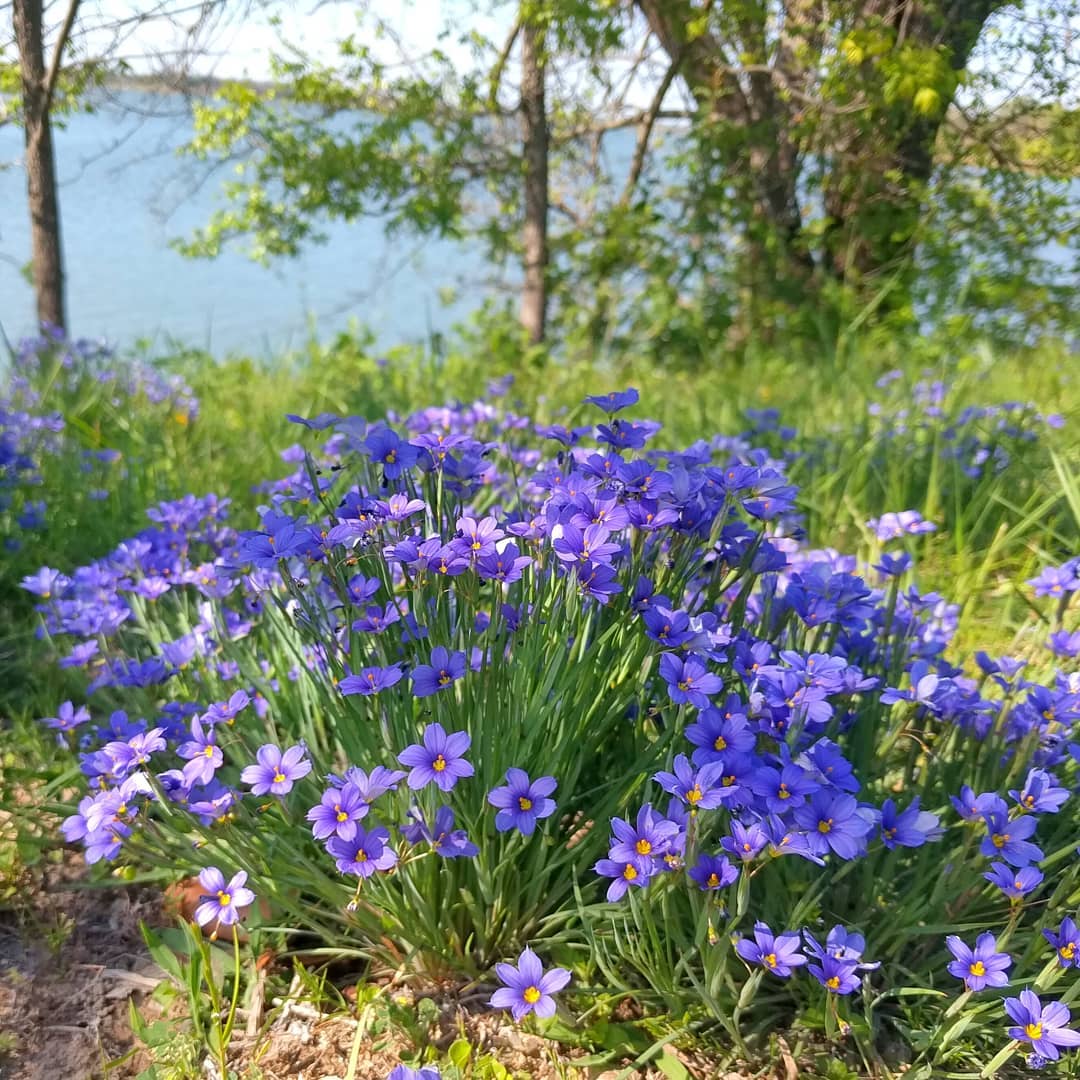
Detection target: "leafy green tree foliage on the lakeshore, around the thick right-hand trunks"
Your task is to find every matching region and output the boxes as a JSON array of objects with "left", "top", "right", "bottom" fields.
[{"left": 170, "top": 0, "right": 1080, "bottom": 363}]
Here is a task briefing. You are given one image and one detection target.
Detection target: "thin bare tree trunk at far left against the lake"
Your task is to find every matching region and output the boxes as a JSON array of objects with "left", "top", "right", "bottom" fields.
[{"left": 14, "top": 0, "right": 67, "bottom": 329}]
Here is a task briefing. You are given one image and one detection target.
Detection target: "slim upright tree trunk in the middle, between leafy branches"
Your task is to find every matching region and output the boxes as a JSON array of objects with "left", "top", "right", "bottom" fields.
[{"left": 522, "top": 22, "right": 548, "bottom": 345}]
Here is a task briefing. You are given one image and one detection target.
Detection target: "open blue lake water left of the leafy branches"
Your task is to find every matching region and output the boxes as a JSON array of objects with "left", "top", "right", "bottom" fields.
[{"left": 0, "top": 94, "right": 492, "bottom": 354}]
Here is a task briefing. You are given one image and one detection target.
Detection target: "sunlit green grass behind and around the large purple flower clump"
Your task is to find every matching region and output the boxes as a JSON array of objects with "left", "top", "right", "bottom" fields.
[{"left": 0, "top": 328, "right": 1080, "bottom": 1078}]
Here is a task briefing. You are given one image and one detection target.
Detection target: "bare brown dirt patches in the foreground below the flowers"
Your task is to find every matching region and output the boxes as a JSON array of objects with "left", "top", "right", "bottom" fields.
[{"left": 0, "top": 853, "right": 751, "bottom": 1080}]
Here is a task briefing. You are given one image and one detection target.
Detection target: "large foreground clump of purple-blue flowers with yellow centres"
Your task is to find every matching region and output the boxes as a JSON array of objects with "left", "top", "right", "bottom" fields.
[{"left": 24, "top": 382, "right": 1080, "bottom": 1071}]
